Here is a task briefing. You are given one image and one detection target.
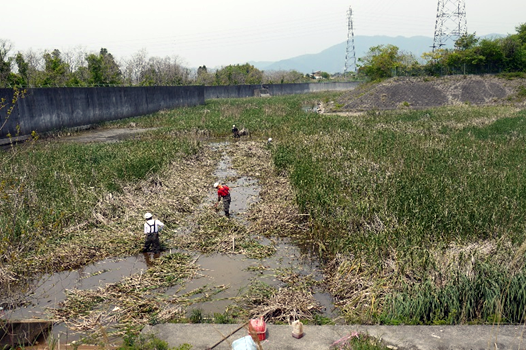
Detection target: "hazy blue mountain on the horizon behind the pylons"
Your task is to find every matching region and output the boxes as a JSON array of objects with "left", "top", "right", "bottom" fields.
[{"left": 249, "top": 34, "right": 508, "bottom": 74}]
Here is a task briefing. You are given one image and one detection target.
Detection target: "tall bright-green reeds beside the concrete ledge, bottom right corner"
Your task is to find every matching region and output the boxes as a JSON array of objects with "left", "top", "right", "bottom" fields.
[{"left": 378, "top": 262, "right": 526, "bottom": 324}]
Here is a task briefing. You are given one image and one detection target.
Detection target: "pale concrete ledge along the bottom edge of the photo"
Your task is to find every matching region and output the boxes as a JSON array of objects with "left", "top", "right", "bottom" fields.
[{"left": 142, "top": 323, "right": 526, "bottom": 350}]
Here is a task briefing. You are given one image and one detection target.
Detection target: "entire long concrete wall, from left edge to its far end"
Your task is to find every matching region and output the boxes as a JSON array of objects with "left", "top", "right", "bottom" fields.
[{"left": 0, "top": 82, "right": 359, "bottom": 140}]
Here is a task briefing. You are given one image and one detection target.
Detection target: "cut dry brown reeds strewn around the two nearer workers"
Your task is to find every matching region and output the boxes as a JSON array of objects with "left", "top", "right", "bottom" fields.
[{"left": 41, "top": 137, "right": 321, "bottom": 331}]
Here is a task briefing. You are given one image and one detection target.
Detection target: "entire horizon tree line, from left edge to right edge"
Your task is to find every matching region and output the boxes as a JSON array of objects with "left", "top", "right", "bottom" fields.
[{"left": 0, "top": 23, "right": 526, "bottom": 87}]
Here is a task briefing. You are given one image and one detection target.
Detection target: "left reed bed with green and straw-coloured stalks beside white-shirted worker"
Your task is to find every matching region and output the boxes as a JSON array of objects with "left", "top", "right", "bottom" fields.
[{"left": 0, "top": 135, "right": 215, "bottom": 298}]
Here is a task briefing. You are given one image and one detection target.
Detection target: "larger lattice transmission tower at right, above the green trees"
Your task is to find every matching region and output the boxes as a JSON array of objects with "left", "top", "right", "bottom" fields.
[{"left": 433, "top": 0, "right": 468, "bottom": 51}]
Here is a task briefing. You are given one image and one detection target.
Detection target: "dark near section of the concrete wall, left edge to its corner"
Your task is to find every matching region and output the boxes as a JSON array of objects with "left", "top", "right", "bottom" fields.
[{"left": 0, "top": 86, "right": 205, "bottom": 138}]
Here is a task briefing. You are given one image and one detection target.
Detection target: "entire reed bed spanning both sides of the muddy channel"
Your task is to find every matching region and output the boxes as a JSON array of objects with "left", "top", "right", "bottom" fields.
[{"left": 0, "top": 88, "right": 526, "bottom": 330}]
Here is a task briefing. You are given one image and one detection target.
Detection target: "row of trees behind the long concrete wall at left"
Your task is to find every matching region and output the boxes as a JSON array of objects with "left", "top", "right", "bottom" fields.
[{"left": 0, "top": 39, "right": 322, "bottom": 87}]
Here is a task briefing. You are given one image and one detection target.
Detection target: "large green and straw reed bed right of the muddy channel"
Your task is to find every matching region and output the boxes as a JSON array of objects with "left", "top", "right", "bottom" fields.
[{"left": 274, "top": 107, "right": 526, "bottom": 323}]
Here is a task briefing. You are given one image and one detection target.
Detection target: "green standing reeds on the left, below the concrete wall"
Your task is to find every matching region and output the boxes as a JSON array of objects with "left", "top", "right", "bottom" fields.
[{"left": 0, "top": 135, "right": 198, "bottom": 254}]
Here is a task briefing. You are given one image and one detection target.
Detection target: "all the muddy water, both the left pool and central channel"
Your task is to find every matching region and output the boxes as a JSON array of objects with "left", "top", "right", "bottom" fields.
[{"left": 3, "top": 136, "right": 335, "bottom": 342}]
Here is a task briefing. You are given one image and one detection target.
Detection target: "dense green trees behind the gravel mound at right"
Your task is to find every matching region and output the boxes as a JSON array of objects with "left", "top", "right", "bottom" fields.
[{"left": 358, "top": 23, "right": 526, "bottom": 80}]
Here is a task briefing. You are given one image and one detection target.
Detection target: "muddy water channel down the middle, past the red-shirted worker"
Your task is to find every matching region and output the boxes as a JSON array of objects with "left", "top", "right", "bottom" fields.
[{"left": 173, "top": 142, "right": 334, "bottom": 317}]
